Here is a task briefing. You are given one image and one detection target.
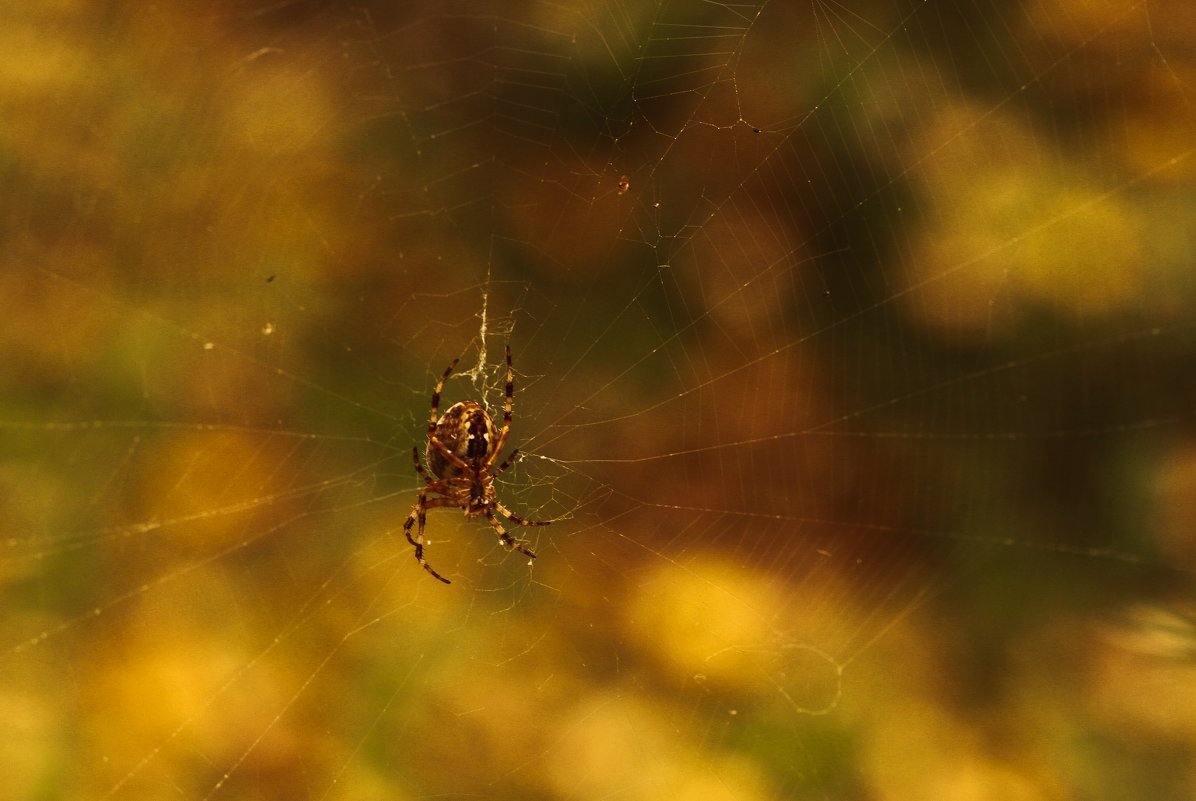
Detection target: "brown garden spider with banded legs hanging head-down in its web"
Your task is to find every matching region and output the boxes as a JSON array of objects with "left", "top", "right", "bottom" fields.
[{"left": 403, "top": 346, "right": 551, "bottom": 585}]
